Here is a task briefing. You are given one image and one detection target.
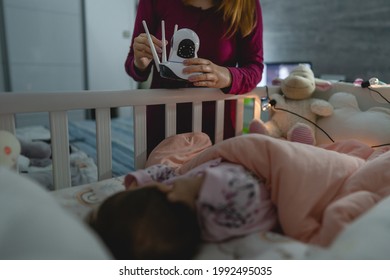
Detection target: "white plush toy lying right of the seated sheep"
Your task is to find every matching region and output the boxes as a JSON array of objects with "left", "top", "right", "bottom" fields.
[{"left": 316, "top": 92, "right": 390, "bottom": 146}]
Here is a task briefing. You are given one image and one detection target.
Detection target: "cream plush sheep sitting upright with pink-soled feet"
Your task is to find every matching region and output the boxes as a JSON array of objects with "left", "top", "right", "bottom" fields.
[{"left": 249, "top": 64, "right": 333, "bottom": 145}]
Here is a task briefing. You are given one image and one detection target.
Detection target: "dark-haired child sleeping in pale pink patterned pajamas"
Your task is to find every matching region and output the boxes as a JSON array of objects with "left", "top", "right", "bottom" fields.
[{"left": 89, "top": 159, "right": 277, "bottom": 259}]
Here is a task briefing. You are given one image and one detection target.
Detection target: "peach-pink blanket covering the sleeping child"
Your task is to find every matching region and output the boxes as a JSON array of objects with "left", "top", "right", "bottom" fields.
[{"left": 148, "top": 134, "right": 390, "bottom": 246}]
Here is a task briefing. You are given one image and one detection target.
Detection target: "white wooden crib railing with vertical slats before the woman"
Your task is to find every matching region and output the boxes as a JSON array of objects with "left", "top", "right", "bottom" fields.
[{"left": 0, "top": 88, "right": 277, "bottom": 189}]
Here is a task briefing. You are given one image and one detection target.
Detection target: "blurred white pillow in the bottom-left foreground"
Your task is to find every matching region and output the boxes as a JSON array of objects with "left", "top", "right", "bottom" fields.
[{"left": 0, "top": 168, "right": 112, "bottom": 260}]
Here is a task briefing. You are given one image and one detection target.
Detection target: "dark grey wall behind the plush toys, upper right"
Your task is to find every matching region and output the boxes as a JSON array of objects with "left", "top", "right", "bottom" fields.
[{"left": 260, "top": 0, "right": 390, "bottom": 83}]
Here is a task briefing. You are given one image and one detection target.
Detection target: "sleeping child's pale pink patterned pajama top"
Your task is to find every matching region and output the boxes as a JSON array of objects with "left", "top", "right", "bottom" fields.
[{"left": 125, "top": 159, "right": 277, "bottom": 242}]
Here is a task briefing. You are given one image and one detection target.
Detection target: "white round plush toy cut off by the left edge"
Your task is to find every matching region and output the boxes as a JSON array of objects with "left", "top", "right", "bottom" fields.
[{"left": 0, "top": 130, "right": 21, "bottom": 169}]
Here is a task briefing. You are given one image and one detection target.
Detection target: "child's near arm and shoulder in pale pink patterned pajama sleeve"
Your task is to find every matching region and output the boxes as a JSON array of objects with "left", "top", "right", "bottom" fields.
[{"left": 197, "top": 163, "right": 276, "bottom": 241}]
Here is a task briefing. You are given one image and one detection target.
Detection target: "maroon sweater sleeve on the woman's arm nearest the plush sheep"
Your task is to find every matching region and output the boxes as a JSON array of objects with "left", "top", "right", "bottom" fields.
[{"left": 223, "top": 1, "right": 264, "bottom": 94}]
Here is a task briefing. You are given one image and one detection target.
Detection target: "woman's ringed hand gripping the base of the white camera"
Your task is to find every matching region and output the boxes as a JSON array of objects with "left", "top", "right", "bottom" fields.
[{"left": 183, "top": 58, "right": 232, "bottom": 88}]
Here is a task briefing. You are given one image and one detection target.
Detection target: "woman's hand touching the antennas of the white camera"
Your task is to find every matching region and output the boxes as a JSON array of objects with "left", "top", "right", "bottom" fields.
[{"left": 133, "top": 33, "right": 166, "bottom": 71}]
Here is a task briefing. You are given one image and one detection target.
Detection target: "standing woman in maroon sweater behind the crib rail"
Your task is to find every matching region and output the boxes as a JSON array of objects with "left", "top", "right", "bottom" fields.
[{"left": 125, "top": 0, "right": 263, "bottom": 154}]
